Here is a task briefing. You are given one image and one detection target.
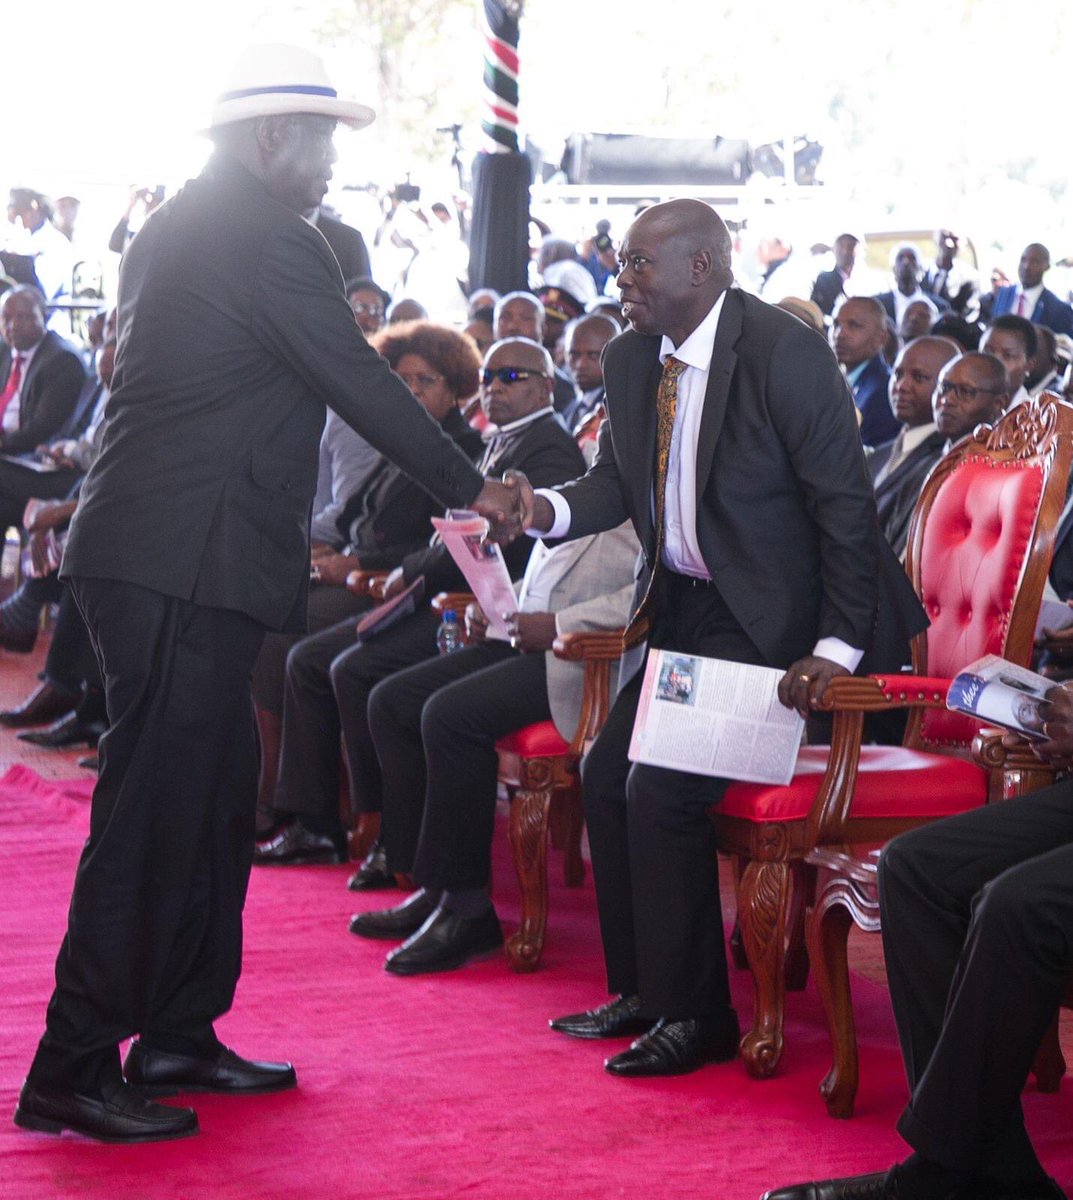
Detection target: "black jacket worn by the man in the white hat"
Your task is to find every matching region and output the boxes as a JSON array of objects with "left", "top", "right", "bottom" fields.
[{"left": 64, "top": 154, "right": 482, "bottom": 631}]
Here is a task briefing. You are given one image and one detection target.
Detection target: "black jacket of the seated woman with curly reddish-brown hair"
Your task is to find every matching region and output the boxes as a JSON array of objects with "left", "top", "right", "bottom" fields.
[{"left": 338, "top": 408, "right": 484, "bottom": 571}]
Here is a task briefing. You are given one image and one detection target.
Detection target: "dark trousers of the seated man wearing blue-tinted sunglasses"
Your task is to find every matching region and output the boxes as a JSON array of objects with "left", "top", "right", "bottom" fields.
[{"left": 276, "top": 608, "right": 439, "bottom": 833}]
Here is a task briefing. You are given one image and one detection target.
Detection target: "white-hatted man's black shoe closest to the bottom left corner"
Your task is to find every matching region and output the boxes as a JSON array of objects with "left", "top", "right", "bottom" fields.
[{"left": 14, "top": 1080, "right": 198, "bottom": 1142}]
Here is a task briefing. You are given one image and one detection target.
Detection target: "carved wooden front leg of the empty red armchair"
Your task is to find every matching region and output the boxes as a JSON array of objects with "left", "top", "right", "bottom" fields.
[{"left": 738, "top": 860, "right": 790, "bottom": 1079}]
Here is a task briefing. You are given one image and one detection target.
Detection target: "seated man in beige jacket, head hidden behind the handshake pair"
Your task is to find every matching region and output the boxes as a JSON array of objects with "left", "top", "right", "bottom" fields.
[{"left": 340, "top": 523, "right": 641, "bottom": 974}]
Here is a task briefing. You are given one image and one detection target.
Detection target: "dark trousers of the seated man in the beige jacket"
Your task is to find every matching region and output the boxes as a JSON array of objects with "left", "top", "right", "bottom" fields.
[{"left": 368, "top": 642, "right": 551, "bottom": 892}]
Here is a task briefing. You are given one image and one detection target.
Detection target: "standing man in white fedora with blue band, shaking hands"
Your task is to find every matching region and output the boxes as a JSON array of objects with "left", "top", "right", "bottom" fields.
[{"left": 16, "top": 39, "right": 514, "bottom": 1142}]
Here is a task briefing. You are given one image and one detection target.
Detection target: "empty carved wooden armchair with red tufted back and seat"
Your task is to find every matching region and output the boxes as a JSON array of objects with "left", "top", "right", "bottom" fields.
[{"left": 712, "top": 395, "right": 1073, "bottom": 1078}]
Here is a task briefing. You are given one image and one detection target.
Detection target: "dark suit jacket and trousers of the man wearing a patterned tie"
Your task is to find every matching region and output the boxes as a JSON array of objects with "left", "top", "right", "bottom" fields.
[{"left": 547, "top": 289, "right": 925, "bottom": 1020}]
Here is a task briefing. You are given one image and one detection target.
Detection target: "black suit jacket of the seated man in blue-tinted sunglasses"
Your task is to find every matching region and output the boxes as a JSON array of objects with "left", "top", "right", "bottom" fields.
[{"left": 402, "top": 413, "right": 583, "bottom": 596}]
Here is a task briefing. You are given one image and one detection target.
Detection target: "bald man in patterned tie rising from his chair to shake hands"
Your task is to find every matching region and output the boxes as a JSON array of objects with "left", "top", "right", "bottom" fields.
[{"left": 508, "top": 200, "right": 925, "bottom": 1075}]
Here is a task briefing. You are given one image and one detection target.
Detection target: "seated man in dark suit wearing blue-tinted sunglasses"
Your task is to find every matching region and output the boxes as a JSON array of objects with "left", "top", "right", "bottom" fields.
[{"left": 254, "top": 337, "right": 585, "bottom": 871}]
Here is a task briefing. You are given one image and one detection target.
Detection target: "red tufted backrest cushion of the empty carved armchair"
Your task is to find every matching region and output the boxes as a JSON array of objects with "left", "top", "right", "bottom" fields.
[{"left": 919, "top": 456, "right": 1043, "bottom": 746}]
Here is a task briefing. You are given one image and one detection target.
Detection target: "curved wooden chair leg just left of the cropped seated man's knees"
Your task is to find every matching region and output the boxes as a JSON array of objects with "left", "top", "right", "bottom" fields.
[{"left": 805, "top": 893, "right": 859, "bottom": 1117}]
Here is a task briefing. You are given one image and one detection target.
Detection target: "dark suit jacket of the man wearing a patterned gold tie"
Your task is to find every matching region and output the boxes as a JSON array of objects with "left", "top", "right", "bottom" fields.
[{"left": 561, "top": 288, "right": 927, "bottom": 678}]
